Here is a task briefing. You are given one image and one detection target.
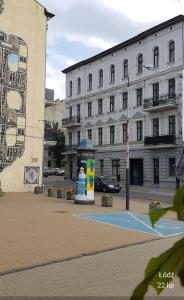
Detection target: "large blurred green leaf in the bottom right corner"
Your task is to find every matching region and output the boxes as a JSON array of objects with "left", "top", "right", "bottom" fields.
[{"left": 131, "top": 238, "right": 184, "bottom": 300}]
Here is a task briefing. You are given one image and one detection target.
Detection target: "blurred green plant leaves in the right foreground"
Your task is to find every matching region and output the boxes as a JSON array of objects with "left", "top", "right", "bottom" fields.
[{"left": 131, "top": 186, "right": 184, "bottom": 300}]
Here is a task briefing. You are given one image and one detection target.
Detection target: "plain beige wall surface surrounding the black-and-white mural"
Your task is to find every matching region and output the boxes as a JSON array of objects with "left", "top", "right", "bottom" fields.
[{"left": 0, "top": 0, "right": 47, "bottom": 192}]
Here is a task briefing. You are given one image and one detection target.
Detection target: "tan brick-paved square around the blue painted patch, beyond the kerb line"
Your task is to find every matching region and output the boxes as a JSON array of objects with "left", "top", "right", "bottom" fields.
[{"left": 0, "top": 193, "right": 171, "bottom": 273}]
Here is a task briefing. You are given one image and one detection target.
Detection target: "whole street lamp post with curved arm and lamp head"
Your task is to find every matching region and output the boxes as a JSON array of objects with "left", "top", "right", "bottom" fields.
[{"left": 126, "top": 65, "right": 153, "bottom": 210}]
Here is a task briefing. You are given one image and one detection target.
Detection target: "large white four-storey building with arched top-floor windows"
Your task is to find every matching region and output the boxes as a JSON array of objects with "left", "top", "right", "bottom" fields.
[{"left": 63, "top": 15, "right": 184, "bottom": 187}]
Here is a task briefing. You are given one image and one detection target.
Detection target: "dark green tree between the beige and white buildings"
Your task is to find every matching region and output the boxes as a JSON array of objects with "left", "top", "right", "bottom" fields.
[{"left": 49, "top": 122, "right": 66, "bottom": 168}]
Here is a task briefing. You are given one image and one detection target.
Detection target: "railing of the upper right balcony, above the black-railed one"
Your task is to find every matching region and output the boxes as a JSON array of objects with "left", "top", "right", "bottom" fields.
[{"left": 144, "top": 95, "right": 176, "bottom": 109}]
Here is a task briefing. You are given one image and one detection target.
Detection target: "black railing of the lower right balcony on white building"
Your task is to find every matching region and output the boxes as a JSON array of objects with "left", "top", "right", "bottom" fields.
[{"left": 144, "top": 134, "right": 176, "bottom": 146}]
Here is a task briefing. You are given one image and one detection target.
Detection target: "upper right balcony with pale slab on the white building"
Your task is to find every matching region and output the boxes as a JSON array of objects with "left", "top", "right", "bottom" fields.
[{"left": 144, "top": 95, "right": 176, "bottom": 113}]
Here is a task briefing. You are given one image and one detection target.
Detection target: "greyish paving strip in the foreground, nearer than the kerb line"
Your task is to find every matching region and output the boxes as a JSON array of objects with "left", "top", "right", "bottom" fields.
[{"left": 0, "top": 237, "right": 184, "bottom": 300}]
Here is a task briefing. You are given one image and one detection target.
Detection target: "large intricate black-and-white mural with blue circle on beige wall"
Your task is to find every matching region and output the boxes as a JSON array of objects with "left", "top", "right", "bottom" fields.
[{"left": 0, "top": 30, "right": 28, "bottom": 172}]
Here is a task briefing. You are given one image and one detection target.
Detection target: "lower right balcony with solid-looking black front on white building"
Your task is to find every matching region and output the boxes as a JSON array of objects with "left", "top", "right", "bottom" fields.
[{"left": 144, "top": 134, "right": 176, "bottom": 149}]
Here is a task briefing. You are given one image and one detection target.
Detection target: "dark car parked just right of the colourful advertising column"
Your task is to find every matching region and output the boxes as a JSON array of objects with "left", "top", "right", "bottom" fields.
[{"left": 95, "top": 177, "right": 121, "bottom": 193}]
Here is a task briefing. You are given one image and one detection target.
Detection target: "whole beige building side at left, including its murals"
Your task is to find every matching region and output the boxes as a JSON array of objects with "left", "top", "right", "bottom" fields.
[{"left": 0, "top": 0, "right": 53, "bottom": 192}]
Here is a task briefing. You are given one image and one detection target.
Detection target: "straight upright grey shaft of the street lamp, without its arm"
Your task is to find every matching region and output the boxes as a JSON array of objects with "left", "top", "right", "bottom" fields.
[{"left": 126, "top": 75, "right": 130, "bottom": 210}]
